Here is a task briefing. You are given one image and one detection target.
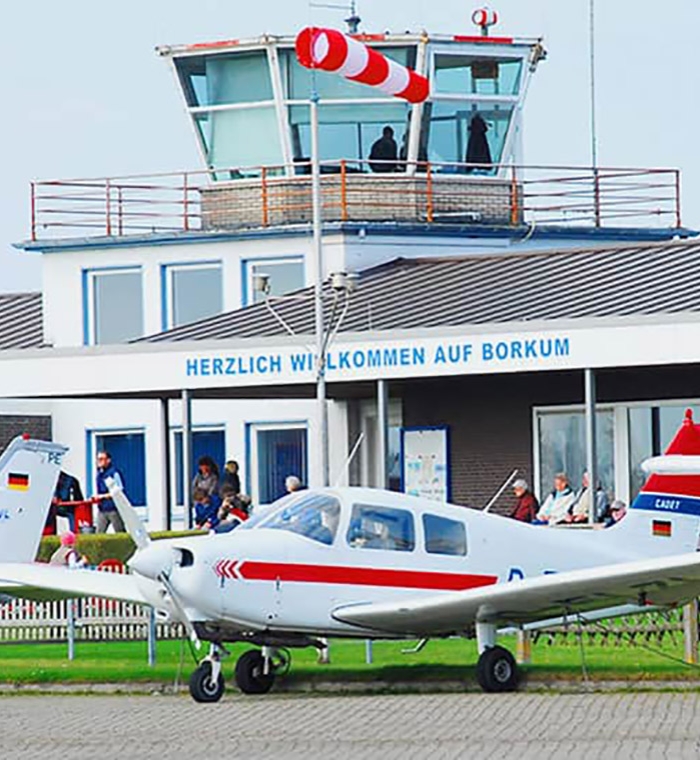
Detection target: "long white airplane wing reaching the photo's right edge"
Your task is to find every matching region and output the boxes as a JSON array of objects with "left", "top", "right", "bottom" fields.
[{"left": 333, "top": 552, "right": 700, "bottom": 637}]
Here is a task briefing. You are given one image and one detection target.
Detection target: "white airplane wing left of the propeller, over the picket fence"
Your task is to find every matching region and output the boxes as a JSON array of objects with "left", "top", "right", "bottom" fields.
[{"left": 0, "top": 562, "right": 154, "bottom": 604}]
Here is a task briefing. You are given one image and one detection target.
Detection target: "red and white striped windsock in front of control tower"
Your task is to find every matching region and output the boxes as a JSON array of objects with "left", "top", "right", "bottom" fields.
[{"left": 296, "top": 26, "right": 430, "bottom": 103}]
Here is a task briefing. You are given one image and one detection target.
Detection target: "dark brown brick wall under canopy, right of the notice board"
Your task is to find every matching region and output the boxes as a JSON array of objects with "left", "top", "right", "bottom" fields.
[{"left": 394, "top": 366, "right": 700, "bottom": 507}]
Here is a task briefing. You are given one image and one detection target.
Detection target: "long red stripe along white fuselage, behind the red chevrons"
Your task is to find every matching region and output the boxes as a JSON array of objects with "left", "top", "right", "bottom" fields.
[{"left": 232, "top": 561, "right": 498, "bottom": 591}]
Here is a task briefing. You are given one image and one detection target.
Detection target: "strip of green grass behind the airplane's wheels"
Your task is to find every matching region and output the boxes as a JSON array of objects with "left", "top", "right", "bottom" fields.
[{"left": 0, "top": 636, "right": 700, "bottom": 686}]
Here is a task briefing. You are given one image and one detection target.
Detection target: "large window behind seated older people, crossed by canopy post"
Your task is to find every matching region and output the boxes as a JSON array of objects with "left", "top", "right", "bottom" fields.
[{"left": 537, "top": 409, "right": 615, "bottom": 499}]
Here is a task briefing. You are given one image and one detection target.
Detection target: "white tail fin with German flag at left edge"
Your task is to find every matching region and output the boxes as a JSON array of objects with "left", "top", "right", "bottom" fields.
[{"left": 0, "top": 436, "right": 68, "bottom": 562}]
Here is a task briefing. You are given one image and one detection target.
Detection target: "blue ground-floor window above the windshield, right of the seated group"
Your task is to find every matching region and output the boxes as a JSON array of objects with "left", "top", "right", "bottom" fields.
[{"left": 247, "top": 423, "right": 308, "bottom": 504}]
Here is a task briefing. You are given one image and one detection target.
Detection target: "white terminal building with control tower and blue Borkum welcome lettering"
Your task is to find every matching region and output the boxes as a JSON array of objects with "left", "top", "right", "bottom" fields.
[{"left": 0, "top": 16, "right": 700, "bottom": 528}]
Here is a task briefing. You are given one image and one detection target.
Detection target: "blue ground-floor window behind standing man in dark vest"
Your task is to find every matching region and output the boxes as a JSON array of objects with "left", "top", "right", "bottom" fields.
[{"left": 85, "top": 430, "right": 146, "bottom": 507}]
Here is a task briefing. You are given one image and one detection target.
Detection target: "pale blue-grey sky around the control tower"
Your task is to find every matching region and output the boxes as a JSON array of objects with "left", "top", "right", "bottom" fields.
[{"left": 0, "top": 0, "right": 700, "bottom": 291}]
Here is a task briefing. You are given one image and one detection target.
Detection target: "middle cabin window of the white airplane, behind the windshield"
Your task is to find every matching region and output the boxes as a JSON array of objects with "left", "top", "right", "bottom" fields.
[{"left": 347, "top": 504, "right": 416, "bottom": 552}]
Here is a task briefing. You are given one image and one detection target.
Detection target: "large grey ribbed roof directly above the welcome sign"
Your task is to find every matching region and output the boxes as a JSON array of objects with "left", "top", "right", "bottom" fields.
[{"left": 139, "top": 241, "right": 700, "bottom": 342}]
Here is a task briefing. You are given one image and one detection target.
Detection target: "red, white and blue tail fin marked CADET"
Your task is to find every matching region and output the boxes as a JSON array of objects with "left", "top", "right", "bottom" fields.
[{"left": 619, "top": 409, "right": 700, "bottom": 556}]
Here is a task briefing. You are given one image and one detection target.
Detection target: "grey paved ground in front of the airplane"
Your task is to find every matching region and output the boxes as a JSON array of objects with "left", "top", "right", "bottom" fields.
[{"left": 0, "top": 692, "right": 700, "bottom": 760}]
